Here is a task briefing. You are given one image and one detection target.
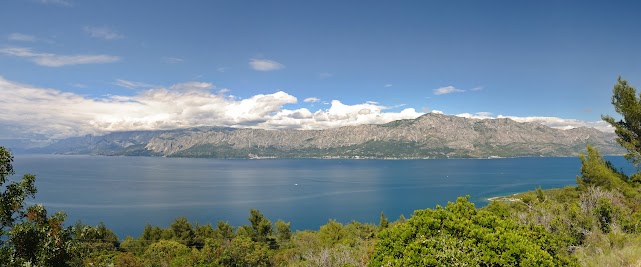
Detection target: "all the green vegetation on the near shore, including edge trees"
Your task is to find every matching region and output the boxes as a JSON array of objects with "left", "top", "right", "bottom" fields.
[{"left": 0, "top": 77, "right": 641, "bottom": 266}]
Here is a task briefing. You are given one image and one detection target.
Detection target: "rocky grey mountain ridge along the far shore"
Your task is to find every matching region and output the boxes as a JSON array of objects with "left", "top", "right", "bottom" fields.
[{"left": 31, "top": 113, "right": 625, "bottom": 158}]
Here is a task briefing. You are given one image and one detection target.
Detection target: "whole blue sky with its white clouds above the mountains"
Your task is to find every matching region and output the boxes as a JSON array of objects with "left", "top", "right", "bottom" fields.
[{"left": 0, "top": 0, "right": 641, "bottom": 146}]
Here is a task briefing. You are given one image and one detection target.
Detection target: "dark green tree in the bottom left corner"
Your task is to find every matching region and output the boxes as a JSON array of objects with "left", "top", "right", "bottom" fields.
[{"left": 0, "top": 146, "right": 76, "bottom": 266}]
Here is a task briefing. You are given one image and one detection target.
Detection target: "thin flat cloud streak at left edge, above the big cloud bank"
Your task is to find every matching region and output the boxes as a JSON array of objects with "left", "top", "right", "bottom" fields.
[{"left": 0, "top": 47, "right": 120, "bottom": 67}]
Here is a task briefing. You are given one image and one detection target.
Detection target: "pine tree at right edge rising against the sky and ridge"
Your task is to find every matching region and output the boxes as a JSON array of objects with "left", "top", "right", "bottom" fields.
[{"left": 601, "top": 77, "right": 641, "bottom": 167}]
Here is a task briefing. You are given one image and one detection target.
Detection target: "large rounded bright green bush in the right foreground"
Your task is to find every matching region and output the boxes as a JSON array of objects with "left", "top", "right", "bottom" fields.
[{"left": 370, "top": 197, "right": 573, "bottom": 266}]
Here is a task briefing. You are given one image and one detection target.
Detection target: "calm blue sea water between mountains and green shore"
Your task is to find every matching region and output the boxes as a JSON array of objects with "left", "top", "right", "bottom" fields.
[{"left": 7, "top": 155, "right": 633, "bottom": 238}]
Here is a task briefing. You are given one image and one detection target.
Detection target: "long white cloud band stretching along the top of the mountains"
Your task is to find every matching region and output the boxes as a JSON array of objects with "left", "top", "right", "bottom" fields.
[{"left": 0, "top": 76, "right": 608, "bottom": 139}]
